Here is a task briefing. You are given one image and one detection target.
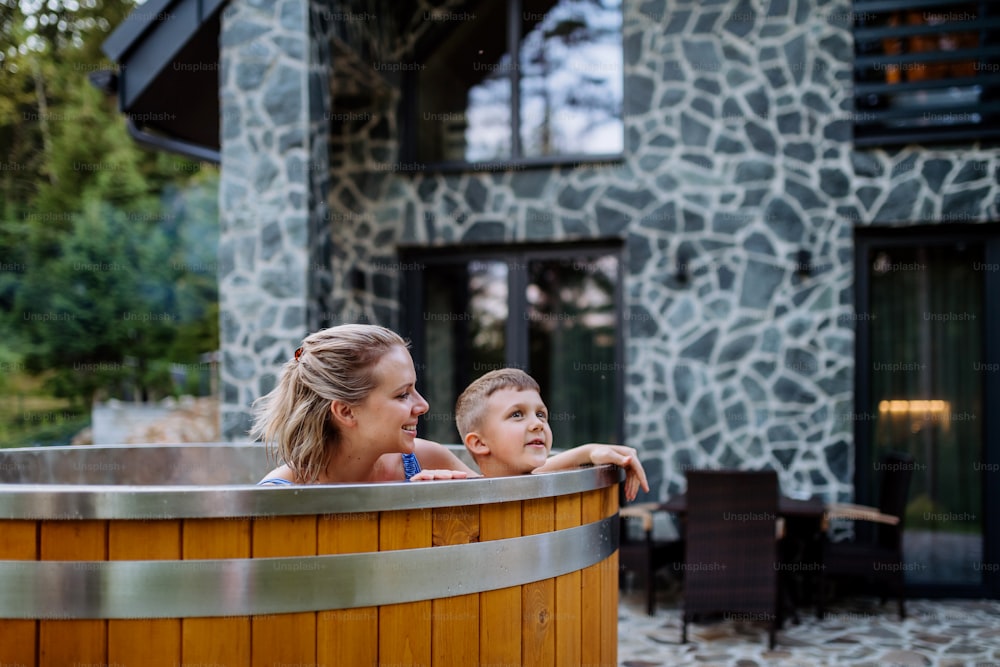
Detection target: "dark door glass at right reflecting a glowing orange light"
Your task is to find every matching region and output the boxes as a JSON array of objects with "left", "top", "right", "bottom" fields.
[{"left": 870, "top": 246, "right": 984, "bottom": 583}]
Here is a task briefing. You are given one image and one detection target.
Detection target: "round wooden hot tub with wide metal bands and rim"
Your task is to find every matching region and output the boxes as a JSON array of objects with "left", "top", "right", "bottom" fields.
[{"left": 0, "top": 444, "right": 622, "bottom": 667}]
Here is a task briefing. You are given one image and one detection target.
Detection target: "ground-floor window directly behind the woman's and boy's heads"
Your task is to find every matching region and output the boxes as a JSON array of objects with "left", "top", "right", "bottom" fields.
[{"left": 403, "top": 246, "right": 625, "bottom": 448}]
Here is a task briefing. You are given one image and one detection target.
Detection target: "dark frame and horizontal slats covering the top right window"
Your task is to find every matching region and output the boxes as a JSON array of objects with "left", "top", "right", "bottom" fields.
[{"left": 852, "top": 0, "right": 1000, "bottom": 147}]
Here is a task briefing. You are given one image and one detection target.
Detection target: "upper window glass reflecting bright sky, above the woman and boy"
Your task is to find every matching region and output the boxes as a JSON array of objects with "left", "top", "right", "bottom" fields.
[{"left": 407, "top": 0, "right": 624, "bottom": 164}]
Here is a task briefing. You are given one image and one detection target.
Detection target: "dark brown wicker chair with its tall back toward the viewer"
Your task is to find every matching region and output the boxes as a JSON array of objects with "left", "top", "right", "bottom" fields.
[{"left": 681, "top": 470, "right": 780, "bottom": 648}]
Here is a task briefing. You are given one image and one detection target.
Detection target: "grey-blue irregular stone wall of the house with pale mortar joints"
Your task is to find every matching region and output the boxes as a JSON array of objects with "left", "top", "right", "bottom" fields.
[{"left": 220, "top": 0, "right": 1000, "bottom": 499}]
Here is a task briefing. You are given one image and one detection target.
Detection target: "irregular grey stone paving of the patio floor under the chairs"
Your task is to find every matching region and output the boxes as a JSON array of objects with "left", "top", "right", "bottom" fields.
[{"left": 618, "top": 591, "right": 1000, "bottom": 667}]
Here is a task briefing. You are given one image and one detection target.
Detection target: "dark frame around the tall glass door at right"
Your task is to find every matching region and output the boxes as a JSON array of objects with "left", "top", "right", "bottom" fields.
[{"left": 853, "top": 225, "right": 1000, "bottom": 599}]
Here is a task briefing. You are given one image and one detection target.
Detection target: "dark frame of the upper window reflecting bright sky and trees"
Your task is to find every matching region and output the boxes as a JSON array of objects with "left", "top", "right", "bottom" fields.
[{"left": 399, "top": 0, "right": 626, "bottom": 173}]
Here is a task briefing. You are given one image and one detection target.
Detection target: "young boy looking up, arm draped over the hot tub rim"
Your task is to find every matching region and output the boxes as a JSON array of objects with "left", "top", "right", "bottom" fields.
[{"left": 455, "top": 368, "right": 649, "bottom": 500}]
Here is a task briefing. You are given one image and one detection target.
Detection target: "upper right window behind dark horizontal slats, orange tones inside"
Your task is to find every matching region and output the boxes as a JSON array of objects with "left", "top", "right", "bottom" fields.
[{"left": 854, "top": 0, "right": 1000, "bottom": 146}]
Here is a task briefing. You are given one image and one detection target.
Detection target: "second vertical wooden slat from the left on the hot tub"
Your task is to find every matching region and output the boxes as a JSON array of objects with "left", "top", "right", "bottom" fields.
[{"left": 38, "top": 520, "right": 108, "bottom": 667}]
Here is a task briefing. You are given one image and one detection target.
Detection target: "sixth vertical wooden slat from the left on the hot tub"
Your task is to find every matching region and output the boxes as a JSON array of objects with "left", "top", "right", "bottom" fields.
[{"left": 316, "top": 512, "right": 379, "bottom": 665}]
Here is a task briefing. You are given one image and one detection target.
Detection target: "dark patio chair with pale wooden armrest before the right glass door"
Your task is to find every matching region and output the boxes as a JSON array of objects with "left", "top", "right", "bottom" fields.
[{"left": 817, "top": 453, "right": 913, "bottom": 620}]
